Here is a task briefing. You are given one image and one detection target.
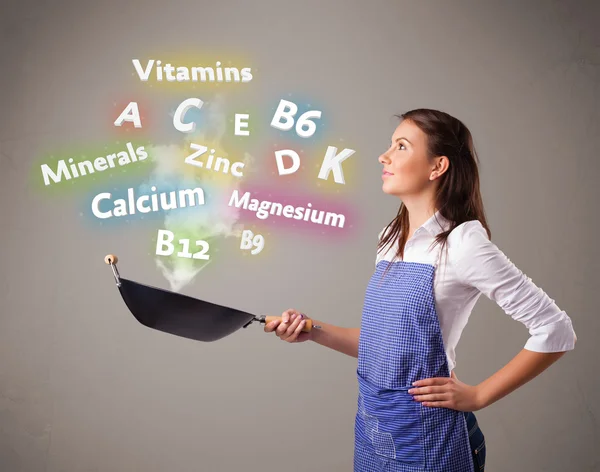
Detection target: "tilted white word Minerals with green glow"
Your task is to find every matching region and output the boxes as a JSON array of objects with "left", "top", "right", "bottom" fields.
[{"left": 41, "top": 143, "right": 148, "bottom": 185}]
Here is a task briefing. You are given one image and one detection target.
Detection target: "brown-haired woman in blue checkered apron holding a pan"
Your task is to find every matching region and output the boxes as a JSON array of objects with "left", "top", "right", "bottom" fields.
[{"left": 265, "top": 109, "right": 577, "bottom": 472}]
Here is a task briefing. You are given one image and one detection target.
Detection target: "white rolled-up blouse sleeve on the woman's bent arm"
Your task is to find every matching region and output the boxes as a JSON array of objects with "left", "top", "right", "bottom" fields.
[{"left": 450, "top": 220, "right": 577, "bottom": 352}]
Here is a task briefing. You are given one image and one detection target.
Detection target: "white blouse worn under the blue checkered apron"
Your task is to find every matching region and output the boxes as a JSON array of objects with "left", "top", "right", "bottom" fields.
[{"left": 376, "top": 211, "right": 577, "bottom": 371}]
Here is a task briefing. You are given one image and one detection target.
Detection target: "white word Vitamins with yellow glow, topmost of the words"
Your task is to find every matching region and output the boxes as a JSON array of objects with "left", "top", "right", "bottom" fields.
[{"left": 132, "top": 59, "right": 252, "bottom": 82}]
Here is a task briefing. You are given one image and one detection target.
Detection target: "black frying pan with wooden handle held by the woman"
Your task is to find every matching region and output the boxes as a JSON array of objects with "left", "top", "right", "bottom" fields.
[{"left": 104, "top": 254, "right": 321, "bottom": 342}]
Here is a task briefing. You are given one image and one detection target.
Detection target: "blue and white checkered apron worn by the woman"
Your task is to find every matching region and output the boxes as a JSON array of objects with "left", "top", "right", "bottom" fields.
[{"left": 354, "top": 249, "right": 474, "bottom": 472}]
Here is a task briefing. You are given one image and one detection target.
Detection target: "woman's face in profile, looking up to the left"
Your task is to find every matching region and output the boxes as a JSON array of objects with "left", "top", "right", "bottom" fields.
[{"left": 379, "top": 120, "right": 439, "bottom": 198}]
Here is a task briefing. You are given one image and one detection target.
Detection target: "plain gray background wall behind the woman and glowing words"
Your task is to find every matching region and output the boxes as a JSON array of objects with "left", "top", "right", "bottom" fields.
[{"left": 0, "top": 0, "right": 600, "bottom": 472}]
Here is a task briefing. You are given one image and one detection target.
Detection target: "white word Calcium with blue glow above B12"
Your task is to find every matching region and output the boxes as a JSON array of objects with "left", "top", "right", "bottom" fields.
[{"left": 92, "top": 186, "right": 204, "bottom": 219}]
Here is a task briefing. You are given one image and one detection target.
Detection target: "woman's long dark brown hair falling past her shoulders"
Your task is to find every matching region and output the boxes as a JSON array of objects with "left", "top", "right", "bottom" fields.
[{"left": 377, "top": 108, "right": 491, "bottom": 274}]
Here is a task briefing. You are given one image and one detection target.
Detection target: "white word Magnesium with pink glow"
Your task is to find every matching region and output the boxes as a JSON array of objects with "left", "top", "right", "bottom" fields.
[{"left": 228, "top": 190, "right": 346, "bottom": 228}]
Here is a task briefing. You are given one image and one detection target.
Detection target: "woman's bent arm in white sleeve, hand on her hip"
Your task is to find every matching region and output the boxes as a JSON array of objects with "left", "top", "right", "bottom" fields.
[{"left": 409, "top": 220, "right": 577, "bottom": 411}]
